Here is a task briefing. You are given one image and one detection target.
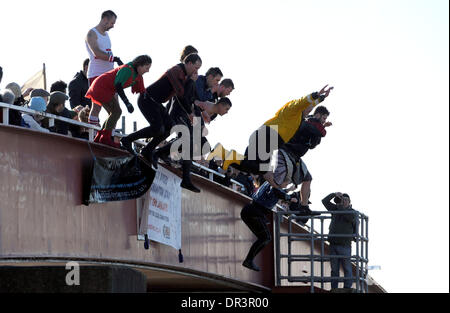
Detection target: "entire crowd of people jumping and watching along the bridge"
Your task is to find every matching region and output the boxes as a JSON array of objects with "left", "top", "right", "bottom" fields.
[{"left": 0, "top": 11, "right": 357, "bottom": 286}]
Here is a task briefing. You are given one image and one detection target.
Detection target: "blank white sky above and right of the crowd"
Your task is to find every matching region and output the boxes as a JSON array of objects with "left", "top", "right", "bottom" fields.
[{"left": 0, "top": 0, "right": 449, "bottom": 292}]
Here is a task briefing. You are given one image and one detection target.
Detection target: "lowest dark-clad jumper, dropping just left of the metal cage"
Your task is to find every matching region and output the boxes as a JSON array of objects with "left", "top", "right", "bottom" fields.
[{"left": 241, "top": 182, "right": 297, "bottom": 272}]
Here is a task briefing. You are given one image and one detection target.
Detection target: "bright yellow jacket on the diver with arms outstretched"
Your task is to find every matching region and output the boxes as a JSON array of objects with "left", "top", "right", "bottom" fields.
[{"left": 264, "top": 94, "right": 321, "bottom": 142}]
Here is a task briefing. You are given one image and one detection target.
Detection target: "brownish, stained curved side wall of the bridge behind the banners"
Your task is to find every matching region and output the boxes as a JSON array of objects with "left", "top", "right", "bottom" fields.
[{"left": 0, "top": 125, "right": 274, "bottom": 288}]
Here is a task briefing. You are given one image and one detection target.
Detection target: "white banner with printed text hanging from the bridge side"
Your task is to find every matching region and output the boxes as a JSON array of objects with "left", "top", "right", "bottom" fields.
[{"left": 144, "top": 166, "right": 181, "bottom": 249}]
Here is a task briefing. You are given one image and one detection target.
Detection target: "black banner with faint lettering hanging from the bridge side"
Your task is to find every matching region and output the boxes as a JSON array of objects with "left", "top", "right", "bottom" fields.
[{"left": 83, "top": 156, "right": 155, "bottom": 205}]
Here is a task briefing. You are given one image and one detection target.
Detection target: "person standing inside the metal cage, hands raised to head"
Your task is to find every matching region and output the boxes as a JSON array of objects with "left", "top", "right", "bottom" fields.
[{"left": 322, "top": 192, "right": 359, "bottom": 289}]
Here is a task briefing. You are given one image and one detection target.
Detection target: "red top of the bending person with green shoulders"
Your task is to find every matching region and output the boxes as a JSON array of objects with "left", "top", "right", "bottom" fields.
[{"left": 85, "top": 64, "right": 145, "bottom": 105}]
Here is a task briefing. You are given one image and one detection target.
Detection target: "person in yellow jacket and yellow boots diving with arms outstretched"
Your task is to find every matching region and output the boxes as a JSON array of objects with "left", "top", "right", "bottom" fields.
[{"left": 207, "top": 85, "right": 333, "bottom": 175}]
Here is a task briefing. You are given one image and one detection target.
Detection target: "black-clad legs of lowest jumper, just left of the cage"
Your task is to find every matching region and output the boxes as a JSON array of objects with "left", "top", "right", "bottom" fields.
[{"left": 241, "top": 202, "right": 272, "bottom": 261}]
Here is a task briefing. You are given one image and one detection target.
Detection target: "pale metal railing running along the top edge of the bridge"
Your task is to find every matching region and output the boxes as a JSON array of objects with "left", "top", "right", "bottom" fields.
[{"left": 0, "top": 102, "right": 245, "bottom": 190}]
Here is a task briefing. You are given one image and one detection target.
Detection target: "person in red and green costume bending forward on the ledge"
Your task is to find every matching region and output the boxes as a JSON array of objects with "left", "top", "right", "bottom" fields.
[{"left": 86, "top": 55, "right": 152, "bottom": 148}]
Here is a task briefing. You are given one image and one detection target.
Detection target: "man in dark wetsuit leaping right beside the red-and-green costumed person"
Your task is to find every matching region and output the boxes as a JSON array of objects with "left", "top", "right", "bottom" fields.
[{"left": 121, "top": 54, "right": 202, "bottom": 192}]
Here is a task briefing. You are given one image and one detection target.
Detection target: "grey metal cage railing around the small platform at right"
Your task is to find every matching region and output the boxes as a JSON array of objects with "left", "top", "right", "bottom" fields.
[{"left": 274, "top": 211, "right": 369, "bottom": 293}]
